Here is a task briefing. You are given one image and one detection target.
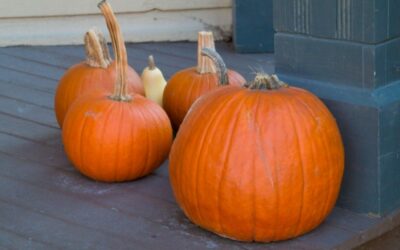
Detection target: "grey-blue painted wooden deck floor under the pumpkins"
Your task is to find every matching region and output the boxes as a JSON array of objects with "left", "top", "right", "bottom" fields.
[{"left": 0, "top": 42, "right": 400, "bottom": 249}]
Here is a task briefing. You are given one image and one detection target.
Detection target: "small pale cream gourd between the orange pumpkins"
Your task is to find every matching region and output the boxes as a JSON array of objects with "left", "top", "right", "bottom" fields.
[{"left": 141, "top": 55, "right": 167, "bottom": 106}]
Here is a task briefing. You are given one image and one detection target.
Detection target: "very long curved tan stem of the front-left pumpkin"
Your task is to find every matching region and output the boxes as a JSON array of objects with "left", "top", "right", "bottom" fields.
[{"left": 98, "top": 0, "right": 132, "bottom": 101}]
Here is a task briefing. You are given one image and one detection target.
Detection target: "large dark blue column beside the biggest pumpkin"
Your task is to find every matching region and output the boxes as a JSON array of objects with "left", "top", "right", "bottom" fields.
[{"left": 274, "top": 0, "right": 400, "bottom": 215}]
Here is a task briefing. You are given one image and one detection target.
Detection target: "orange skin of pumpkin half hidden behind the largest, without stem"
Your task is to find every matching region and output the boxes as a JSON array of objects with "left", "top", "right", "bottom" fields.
[{"left": 163, "top": 67, "right": 246, "bottom": 129}]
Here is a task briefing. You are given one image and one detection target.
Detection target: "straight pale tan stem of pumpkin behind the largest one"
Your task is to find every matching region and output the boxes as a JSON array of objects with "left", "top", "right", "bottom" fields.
[{"left": 197, "top": 31, "right": 217, "bottom": 74}]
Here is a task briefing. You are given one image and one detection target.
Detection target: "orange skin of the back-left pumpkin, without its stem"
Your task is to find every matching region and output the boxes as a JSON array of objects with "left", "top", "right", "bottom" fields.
[{"left": 54, "top": 62, "right": 144, "bottom": 128}]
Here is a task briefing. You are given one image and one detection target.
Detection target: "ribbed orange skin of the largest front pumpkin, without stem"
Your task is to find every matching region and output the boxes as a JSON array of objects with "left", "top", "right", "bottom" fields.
[{"left": 169, "top": 87, "right": 344, "bottom": 242}]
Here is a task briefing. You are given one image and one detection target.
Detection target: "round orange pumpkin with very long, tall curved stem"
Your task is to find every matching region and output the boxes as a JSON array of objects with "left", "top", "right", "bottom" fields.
[{"left": 62, "top": 1, "right": 172, "bottom": 182}]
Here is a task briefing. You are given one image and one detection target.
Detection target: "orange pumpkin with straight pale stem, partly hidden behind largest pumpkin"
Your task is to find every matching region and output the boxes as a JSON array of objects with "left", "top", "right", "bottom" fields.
[{"left": 163, "top": 31, "right": 245, "bottom": 129}]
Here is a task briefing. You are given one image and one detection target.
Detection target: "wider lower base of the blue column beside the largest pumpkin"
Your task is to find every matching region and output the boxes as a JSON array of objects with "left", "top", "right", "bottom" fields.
[{"left": 277, "top": 72, "right": 400, "bottom": 216}]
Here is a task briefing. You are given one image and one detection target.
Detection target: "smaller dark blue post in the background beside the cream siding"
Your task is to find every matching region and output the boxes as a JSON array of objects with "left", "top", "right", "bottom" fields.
[{"left": 232, "top": 0, "right": 274, "bottom": 53}]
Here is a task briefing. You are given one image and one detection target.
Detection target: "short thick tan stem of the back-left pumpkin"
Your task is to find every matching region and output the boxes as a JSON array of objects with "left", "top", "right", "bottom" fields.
[{"left": 84, "top": 28, "right": 111, "bottom": 69}]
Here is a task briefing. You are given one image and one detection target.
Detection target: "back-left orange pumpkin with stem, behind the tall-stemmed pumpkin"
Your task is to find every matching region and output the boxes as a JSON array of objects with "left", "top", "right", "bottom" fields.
[{"left": 54, "top": 29, "right": 144, "bottom": 127}]
